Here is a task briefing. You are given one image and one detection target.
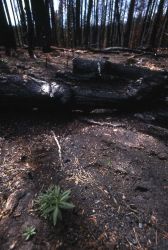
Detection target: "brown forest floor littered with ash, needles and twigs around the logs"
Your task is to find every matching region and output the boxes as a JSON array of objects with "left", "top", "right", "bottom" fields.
[{"left": 0, "top": 47, "right": 168, "bottom": 250}]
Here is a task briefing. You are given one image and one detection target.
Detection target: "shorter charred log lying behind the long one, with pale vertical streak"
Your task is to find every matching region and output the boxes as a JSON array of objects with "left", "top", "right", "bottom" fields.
[{"left": 73, "top": 58, "right": 168, "bottom": 80}]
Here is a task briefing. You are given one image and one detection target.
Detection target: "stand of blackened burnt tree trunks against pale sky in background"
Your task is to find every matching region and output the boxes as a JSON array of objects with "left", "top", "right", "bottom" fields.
[{"left": 0, "top": 0, "right": 168, "bottom": 53}]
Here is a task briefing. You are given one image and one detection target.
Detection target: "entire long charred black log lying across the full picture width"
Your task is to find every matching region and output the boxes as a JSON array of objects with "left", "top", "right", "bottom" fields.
[{"left": 0, "top": 72, "right": 168, "bottom": 111}]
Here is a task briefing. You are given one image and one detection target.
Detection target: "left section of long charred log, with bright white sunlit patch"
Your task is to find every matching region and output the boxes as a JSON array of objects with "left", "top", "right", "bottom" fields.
[{"left": 0, "top": 75, "right": 71, "bottom": 110}]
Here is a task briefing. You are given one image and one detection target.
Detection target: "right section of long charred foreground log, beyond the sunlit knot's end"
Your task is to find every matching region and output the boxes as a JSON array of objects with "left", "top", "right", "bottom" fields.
[{"left": 72, "top": 73, "right": 168, "bottom": 111}]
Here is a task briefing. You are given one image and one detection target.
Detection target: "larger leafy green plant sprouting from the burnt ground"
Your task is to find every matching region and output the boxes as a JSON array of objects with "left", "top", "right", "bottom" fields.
[{"left": 35, "top": 186, "right": 74, "bottom": 226}]
